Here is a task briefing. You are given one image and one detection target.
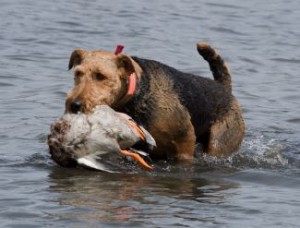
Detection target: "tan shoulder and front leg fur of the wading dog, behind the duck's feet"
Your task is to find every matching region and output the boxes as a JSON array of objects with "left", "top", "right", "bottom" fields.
[{"left": 144, "top": 70, "right": 196, "bottom": 161}]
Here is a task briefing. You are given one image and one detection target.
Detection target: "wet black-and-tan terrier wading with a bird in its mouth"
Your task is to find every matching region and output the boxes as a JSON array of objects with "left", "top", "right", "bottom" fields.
[{"left": 66, "top": 42, "right": 245, "bottom": 161}]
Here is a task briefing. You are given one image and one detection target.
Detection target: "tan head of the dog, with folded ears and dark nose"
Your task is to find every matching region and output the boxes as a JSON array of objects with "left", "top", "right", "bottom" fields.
[{"left": 65, "top": 49, "right": 138, "bottom": 113}]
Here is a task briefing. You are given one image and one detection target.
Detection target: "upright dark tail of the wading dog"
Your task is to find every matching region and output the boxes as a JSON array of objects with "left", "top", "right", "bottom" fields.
[{"left": 197, "top": 42, "right": 231, "bottom": 93}]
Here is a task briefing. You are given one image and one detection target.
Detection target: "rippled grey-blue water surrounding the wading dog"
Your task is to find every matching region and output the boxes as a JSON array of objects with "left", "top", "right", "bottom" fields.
[{"left": 0, "top": 0, "right": 300, "bottom": 227}]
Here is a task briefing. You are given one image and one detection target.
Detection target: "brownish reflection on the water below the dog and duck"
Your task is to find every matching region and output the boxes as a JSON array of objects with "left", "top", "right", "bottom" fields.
[{"left": 49, "top": 167, "right": 238, "bottom": 223}]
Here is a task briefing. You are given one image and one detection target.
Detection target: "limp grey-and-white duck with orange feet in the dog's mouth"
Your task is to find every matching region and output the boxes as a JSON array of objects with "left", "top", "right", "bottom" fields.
[{"left": 48, "top": 105, "right": 156, "bottom": 173}]
